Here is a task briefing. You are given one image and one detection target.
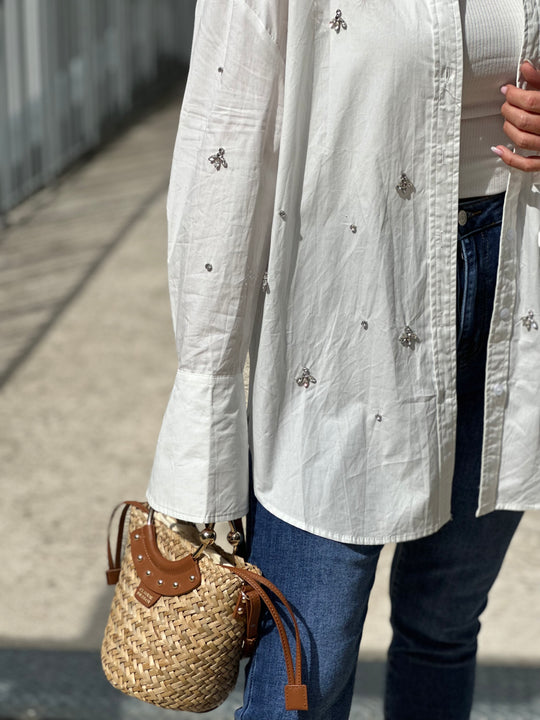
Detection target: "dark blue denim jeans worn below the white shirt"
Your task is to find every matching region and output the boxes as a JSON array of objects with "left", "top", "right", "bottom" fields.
[{"left": 235, "top": 195, "right": 521, "bottom": 720}]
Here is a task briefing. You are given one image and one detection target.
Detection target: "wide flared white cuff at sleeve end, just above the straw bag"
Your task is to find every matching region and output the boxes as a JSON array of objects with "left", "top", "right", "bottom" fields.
[{"left": 146, "top": 370, "right": 248, "bottom": 522}]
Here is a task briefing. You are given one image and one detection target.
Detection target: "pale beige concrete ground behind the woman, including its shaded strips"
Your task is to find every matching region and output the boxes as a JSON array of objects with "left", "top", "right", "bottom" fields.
[{"left": 0, "top": 81, "right": 540, "bottom": 720}]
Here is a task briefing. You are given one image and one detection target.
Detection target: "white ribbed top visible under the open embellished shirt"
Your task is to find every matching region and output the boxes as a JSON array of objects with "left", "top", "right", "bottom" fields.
[{"left": 459, "top": 0, "right": 525, "bottom": 198}]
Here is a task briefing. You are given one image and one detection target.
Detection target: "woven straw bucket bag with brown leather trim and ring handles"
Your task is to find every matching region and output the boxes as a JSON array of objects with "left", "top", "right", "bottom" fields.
[{"left": 101, "top": 501, "right": 307, "bottom": 712}]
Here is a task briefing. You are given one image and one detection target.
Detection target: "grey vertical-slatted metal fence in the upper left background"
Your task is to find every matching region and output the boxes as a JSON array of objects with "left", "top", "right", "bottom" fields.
[{"left": 0, "top": 0, "right": 196, "bottom": 215}]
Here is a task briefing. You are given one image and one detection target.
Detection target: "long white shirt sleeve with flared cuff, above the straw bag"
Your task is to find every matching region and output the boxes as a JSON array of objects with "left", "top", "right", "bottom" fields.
[{"left": 147, "top": 0, "right": 284, "bottom": 522}]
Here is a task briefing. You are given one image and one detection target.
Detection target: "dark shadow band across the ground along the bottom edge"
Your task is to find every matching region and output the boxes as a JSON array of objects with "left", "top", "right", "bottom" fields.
[{"left": 0, "top": 649, "right": 540, "bottom": 720}]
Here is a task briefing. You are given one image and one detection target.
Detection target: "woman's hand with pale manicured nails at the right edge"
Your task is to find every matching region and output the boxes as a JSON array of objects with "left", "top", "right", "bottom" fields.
[{"left": 491, "top": 62, "right": 540, "bottom": 172}]
